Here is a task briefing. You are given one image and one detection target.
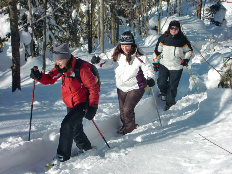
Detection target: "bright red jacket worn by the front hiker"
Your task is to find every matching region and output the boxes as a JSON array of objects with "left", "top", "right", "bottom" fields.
[{"left": 39, "top": 55, "right": 99, "bottom": 108}]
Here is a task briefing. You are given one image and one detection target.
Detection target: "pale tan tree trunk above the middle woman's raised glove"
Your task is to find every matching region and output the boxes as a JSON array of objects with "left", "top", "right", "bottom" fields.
[{"left": 100, "top": 0, "right": 104, "bottom": 53}]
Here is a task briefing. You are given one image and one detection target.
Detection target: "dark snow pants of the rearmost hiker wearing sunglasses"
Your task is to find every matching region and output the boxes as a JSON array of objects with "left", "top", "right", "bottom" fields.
[{"left": 157, "top": 64, "right": 183, "bottom": 107}]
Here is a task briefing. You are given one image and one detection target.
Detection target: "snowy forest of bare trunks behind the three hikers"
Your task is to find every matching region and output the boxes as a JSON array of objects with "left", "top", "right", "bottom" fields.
[{"left": 0, "top": 0, "right": 214, "bottom": 92}]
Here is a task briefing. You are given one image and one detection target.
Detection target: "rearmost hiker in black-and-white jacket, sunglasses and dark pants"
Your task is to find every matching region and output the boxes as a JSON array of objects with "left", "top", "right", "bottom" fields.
[{"left": 153, "top": 21, "right": 193, "bottom": 110}]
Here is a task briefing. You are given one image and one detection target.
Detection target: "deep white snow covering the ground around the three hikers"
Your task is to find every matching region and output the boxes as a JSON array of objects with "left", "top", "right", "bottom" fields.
[{"left": 0, "top": 3, "right": 232, "bottom": 174}]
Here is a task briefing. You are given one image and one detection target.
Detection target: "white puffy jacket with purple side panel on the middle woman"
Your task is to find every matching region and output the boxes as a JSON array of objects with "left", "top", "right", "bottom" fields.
[{"left": 99, "top": 48, "right": 155, "bottom": 92}]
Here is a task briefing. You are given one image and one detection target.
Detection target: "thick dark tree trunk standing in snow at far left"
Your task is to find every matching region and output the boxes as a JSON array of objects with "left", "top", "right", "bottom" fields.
[{"left": 8, "top": 0, "right": 21, "bottom": 92}]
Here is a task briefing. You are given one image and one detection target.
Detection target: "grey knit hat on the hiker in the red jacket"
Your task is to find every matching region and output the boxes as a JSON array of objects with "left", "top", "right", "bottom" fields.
[{"left": 53, "top": 43, "right": 71, "bottom": 60}]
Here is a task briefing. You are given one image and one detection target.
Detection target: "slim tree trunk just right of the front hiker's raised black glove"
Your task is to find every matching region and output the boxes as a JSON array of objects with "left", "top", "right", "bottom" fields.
[{"left": 42, "top": 0, "right": 47, "bottom": 73}]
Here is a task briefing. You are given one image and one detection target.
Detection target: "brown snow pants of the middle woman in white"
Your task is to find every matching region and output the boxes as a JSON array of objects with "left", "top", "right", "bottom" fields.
[{"left": 117, "top": 89, "right": 144, "bottom": 134}]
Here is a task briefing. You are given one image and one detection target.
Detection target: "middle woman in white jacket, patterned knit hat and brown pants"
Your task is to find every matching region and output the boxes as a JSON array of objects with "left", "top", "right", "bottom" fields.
[{"left": 91, "top": 31, "right": 155, "bottom": 135}]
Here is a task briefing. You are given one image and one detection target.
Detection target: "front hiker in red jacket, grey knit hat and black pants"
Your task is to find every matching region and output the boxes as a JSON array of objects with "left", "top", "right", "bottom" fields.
[{"left": 30, "top": 43, "right": 99, "bottom": 164}]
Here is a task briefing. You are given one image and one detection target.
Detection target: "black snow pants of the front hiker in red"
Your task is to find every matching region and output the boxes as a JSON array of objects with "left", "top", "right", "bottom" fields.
[{"left": 57, "top": 103, "right": 91, "bottom": 161}]
